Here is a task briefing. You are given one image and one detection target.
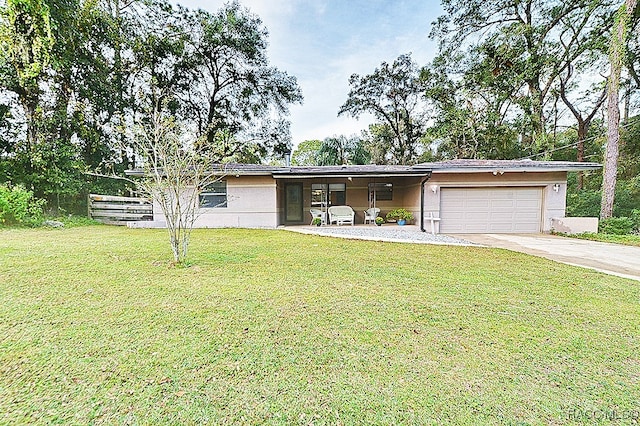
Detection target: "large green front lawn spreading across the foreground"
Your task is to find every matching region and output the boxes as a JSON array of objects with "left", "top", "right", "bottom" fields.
[{"left": 0, "top": 226, "right": 640, "bottom": 425}]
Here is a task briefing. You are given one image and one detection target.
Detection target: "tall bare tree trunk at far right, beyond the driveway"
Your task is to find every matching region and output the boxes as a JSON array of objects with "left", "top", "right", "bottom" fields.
[{"left": 600, "top": 0, "right": 638, "bottom": 219}]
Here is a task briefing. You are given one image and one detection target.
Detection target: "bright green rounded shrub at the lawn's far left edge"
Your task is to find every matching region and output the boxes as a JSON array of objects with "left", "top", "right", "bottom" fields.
[{"left": 0, "top": 185, "right": 45, "bottom": 226}]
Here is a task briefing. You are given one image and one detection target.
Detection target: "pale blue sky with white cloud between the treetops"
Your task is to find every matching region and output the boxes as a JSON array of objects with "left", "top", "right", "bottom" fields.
[{"left": 168, "top": 0, "right": 442, "bottom": 146}]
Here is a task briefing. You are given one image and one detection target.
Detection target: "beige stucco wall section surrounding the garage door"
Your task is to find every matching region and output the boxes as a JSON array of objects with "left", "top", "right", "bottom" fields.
[{"left": 418, "top": 171, "right": 567, "bottom": 232}]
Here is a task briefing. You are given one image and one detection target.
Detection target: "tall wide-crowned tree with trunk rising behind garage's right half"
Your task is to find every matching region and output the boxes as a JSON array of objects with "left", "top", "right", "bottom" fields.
[{"left": 432, "top": 0, "right": 612, "bottom": 148}]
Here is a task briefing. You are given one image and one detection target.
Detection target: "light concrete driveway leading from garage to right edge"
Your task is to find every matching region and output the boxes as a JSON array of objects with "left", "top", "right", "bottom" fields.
[{"left": 454, "top": 234, "right": 640, "bottom": 281}]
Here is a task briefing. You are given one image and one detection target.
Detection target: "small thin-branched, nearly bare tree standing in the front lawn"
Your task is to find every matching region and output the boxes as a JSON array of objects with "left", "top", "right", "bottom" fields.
[{"left": 133, "top": 102, "right": 224, "bottom": 263}]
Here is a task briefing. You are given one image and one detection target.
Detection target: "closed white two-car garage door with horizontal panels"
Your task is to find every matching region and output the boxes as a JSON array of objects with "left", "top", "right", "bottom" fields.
[{"left": 440, "top": 187, "right": 542, "bottom": 234}]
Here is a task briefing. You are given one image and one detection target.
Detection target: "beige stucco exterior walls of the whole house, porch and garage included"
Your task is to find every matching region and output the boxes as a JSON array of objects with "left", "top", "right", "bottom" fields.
[{"left": 145, "top": 171, "right": 567, "bottom": 232}]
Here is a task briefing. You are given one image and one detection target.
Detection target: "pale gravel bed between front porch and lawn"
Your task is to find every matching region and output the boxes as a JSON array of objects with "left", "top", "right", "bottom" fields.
[{"left": 299, "top": 225, "right": 475, "bottom": 245}]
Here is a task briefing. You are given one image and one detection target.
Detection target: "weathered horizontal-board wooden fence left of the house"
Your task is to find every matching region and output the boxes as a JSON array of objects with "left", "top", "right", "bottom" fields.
[{"left": 88, "top": 194, "right": 153, "bottom": 225}]
